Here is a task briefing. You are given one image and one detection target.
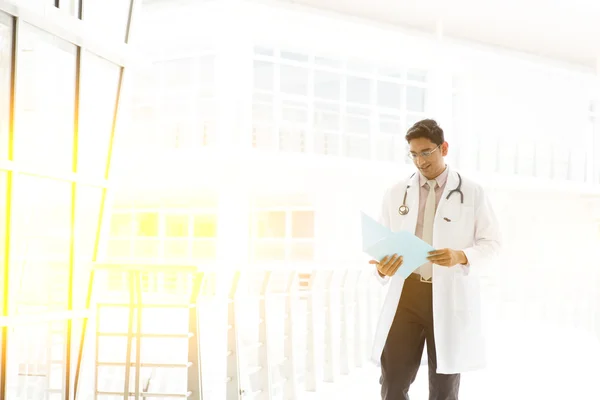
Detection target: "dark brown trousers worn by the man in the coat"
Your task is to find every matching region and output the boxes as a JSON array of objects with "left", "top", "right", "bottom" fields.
[{"left": 380, "top": 275, "right": 460, "bottom": 400}]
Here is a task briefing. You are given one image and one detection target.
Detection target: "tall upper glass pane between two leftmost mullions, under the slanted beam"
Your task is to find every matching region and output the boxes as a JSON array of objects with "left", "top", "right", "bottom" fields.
[{"left": 15, "top": 24, "right": 76, "bottom": 170}]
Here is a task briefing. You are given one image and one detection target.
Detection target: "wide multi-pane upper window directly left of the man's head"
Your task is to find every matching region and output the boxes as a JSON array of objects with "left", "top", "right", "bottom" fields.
[{"left": 252, "top": 49, "right": 427, "bottom": 160}]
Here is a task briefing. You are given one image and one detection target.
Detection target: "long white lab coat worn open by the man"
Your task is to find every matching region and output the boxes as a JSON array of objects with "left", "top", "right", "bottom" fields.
[{"left": 371, "top": 170, "right": 500, "bottom": 374}]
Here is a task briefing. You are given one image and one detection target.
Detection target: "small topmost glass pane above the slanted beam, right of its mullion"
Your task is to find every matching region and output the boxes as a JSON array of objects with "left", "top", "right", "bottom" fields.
[{"left": 83, "top": 0, "right": 132, "bottom": 42}]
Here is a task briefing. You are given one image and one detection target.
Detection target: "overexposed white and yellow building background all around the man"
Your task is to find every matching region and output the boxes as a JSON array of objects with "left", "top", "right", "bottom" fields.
[{"left": 0, "top": 0, "right": 600, "bottom": 400}]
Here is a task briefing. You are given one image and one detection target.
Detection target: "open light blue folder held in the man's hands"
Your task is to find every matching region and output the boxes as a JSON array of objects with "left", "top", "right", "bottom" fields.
[{"left": 361, "top": 212, "right": 434, "bottom": 279}]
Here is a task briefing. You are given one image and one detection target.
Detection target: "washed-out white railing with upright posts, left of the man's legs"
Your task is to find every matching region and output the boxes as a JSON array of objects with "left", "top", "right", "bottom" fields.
[{"left": 78, "top": 264, "right": 384, "bottom": 400}]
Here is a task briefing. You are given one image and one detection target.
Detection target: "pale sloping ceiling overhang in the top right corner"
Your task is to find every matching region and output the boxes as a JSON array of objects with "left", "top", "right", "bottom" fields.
[{"left": 279, "top": 0, "right": 600, "bottom": 72}]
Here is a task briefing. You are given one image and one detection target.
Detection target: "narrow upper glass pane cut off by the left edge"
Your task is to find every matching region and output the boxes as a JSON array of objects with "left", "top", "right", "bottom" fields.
[{"left": 0, "top": 12, "right": 13, "bottom": 160}]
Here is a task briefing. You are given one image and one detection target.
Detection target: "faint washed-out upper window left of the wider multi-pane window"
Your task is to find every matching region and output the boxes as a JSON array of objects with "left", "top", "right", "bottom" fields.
[{"left": 127, "top": 54, "right": 217, "bottom": 148}]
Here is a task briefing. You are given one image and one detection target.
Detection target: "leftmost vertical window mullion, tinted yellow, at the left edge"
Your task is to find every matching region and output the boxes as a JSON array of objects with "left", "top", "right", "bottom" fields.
[{"left": 0, "top": 14, "right": 20, "bottom": 398}]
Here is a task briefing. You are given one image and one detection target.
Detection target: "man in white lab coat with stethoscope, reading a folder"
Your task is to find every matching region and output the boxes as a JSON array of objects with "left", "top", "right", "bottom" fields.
[{"left": 370, "top": 119, "right": 500, "bottom": 400}]
